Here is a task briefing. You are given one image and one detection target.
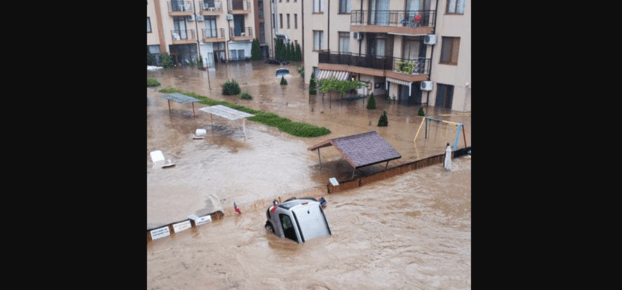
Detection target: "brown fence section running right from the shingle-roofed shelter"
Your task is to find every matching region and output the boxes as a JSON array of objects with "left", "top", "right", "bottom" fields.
[{"left": 326, "top": 147, "right": 471, "bottom": 194}]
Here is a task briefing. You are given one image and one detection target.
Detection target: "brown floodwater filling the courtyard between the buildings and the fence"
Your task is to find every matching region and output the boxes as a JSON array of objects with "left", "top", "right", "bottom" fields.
[{"left": 146, "top": 62, "right": 471, "bottom": 229}]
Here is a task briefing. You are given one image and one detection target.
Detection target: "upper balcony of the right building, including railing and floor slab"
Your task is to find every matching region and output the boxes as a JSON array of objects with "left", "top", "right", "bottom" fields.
[{"left": 350, "top": 10, "right": 436, "bottom": 34}]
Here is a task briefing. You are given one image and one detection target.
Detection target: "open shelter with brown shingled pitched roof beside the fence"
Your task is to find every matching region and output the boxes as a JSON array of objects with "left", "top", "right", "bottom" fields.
[{"left": 307, "top": 131, "right": 402, "bottom": 178}]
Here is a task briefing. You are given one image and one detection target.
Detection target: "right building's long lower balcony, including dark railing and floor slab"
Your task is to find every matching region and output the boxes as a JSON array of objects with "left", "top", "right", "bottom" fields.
[{"left": 318, "top": 50, "right": 431, "bottom": 82}]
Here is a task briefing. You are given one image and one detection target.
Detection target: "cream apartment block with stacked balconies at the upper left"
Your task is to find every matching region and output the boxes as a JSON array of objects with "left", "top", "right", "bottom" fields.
[{"left": 147, "top": 0, "right": 255, "bottom": 66}]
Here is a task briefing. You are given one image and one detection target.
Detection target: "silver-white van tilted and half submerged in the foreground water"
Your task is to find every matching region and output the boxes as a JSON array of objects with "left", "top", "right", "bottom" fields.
[{"left": 265, "top": 198, "right": 331, "bottom": 243}]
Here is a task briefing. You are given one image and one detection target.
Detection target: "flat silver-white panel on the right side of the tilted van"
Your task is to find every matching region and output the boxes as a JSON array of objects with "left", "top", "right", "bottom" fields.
[{"left": 292, "top": 202, "right": 330, "bottom": 242}]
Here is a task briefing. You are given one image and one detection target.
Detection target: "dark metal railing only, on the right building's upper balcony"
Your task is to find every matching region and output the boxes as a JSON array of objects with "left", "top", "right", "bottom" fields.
[{"left": 350, "top": 10, "right": 436, "bottom": 27}]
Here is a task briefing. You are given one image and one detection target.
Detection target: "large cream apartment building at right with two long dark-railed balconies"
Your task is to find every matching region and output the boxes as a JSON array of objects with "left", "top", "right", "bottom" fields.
[{"left": 304, "top": 0, "right": 471, "bottom": 111}]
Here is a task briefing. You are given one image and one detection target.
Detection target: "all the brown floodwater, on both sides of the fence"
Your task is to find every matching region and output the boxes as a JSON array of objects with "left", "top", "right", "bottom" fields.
[{"left": 146, "top": 62, "right": 471, "bottom": 289}]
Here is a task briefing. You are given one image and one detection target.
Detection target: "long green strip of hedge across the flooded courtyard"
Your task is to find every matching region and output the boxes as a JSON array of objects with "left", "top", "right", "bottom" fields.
[{"left": 160, "top": 88, "right": 330, "bottom": 137}]
